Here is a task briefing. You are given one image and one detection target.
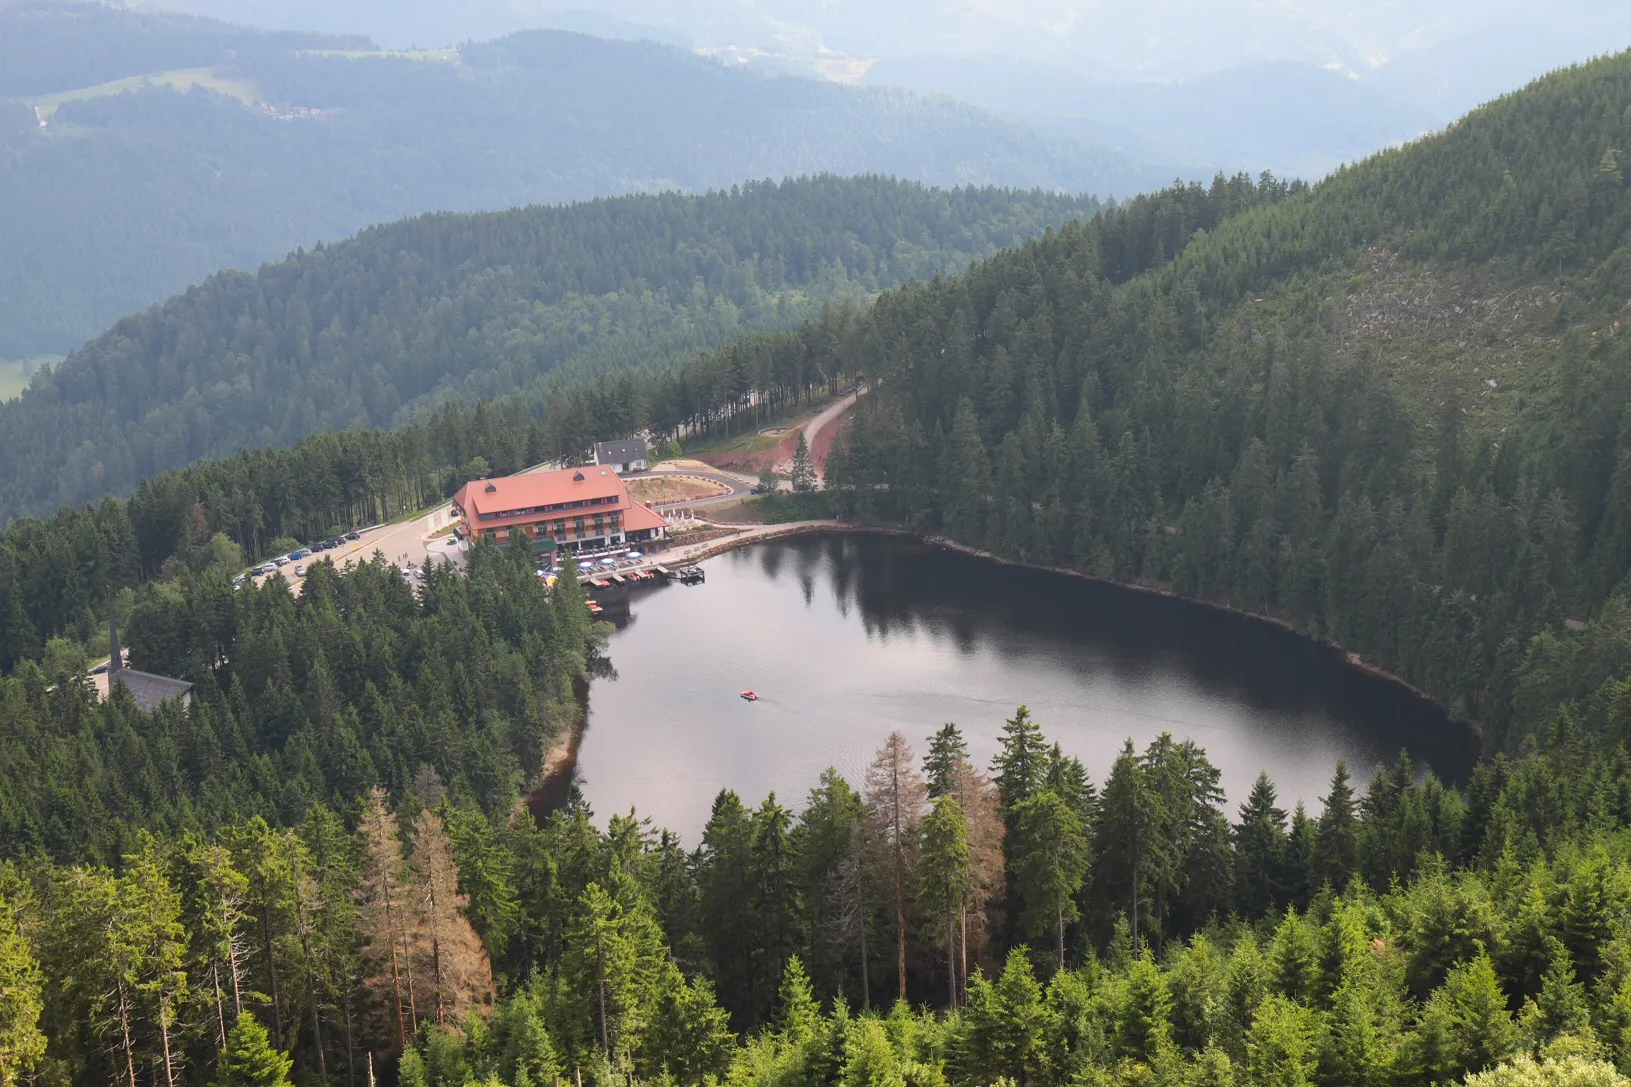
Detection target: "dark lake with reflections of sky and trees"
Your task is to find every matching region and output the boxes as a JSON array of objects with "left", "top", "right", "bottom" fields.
[{"left": 577, "top": 535, "right": 1476, "bottom": 845}]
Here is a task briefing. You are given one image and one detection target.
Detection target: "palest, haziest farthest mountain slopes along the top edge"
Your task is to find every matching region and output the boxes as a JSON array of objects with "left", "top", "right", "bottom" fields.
[{"left": 133, "top": 0, "right": 1631, "bottom": 127}]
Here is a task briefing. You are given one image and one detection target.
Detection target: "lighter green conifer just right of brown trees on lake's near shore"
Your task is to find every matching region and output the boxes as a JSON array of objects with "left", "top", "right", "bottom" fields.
[{"left": 1008, "top": 790, "right": 1088, "bottom": 971}]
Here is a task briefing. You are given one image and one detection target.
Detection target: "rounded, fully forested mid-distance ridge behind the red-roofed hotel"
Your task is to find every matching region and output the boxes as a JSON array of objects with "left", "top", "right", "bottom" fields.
[{"left": 0, "top": 176, "right": 1098, "bottom": 522}]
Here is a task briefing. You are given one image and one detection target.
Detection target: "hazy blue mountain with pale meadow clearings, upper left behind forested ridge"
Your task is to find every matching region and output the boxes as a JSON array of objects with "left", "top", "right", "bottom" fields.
[{"left": 0, "top": 0, "right": 1174, "bottom": 359}]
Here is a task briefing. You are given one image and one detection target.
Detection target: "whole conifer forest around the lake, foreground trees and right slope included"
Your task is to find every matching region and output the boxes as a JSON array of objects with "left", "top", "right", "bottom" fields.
[{"left": 12, "top": 31, "right": 1631, "bottom": 1087}]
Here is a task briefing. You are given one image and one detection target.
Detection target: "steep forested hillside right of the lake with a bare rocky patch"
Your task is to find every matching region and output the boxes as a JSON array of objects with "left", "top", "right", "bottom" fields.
[{"left": 815, "top": 55, "right": 1631, "bottom": 748}]
